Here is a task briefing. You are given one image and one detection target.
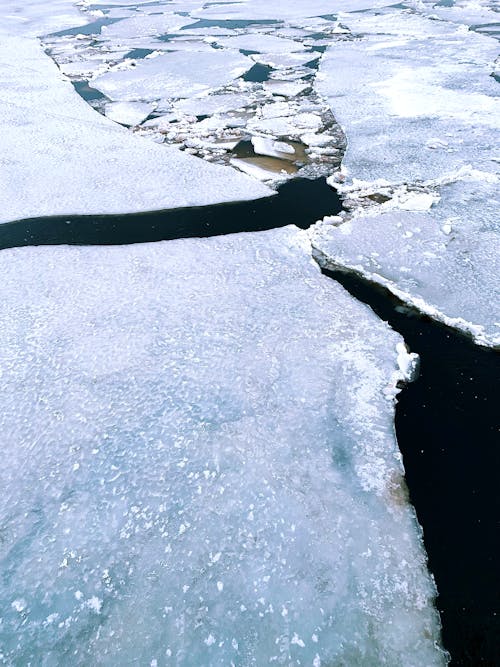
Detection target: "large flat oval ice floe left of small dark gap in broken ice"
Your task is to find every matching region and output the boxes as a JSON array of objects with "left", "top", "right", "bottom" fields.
[{"left": 92, "top": 49, "right": 252, "bottom": 101}]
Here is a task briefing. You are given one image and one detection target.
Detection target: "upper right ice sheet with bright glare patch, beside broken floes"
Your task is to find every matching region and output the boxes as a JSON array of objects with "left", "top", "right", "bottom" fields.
[{"left": 315, "top": 10, "right": 500, "bottom": 183}]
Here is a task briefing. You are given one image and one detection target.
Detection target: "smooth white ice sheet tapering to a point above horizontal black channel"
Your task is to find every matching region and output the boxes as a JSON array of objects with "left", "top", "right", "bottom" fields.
[{"left": 0, "top": 35, "right": 272, "bottom": 222}]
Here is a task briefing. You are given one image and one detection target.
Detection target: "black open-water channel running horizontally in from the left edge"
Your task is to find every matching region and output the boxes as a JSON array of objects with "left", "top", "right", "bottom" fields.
[{"left": 0, "top": 178, "right": 341, "bottom": 248}]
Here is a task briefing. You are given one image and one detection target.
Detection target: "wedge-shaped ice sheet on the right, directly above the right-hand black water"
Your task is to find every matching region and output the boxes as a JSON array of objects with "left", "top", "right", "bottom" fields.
[{"left": 313, "top": 170, "right": 500, "bottom": 347}]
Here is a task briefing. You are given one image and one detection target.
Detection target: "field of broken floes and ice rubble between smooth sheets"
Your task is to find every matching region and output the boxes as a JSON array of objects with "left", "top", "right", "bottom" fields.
[{"left": 40, "top": 2, "right": 343, "bottom": 184}]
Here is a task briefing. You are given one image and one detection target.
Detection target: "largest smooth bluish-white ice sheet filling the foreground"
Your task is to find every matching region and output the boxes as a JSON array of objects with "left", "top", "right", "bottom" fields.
[{"left": 0, "top": 228, "right": 445, "bottom": 667}]
